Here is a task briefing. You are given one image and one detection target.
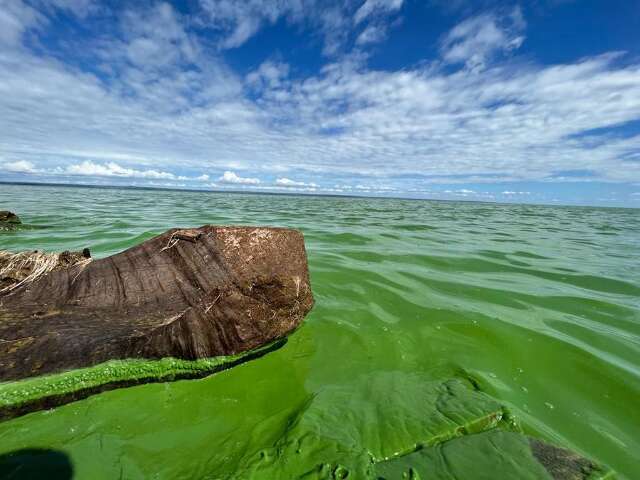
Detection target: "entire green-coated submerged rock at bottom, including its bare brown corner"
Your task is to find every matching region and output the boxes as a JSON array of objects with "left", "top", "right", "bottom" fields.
[{"left": 231, "top": 372, "right": 613, "bottom": 480}]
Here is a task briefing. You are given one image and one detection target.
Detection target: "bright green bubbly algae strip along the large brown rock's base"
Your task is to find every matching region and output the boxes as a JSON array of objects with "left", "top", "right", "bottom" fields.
[{"left": 0, "top": 339, "right": 286, "bottom": 411}]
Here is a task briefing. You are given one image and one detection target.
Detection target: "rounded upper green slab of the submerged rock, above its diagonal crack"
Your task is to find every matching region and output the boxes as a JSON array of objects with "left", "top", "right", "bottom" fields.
[{"left": 228, "top": 372, "right": 517, "bottom": 480}]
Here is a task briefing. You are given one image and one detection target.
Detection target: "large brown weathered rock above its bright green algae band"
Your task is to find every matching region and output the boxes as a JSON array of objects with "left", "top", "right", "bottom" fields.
[{"left": 0, "top": 225, "right": 313, "bottom": 381}]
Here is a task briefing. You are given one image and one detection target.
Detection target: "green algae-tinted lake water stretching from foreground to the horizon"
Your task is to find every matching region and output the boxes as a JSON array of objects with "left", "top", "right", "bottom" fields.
[{"left": 0, "top": 185, "right": 640, "bottom": 480}]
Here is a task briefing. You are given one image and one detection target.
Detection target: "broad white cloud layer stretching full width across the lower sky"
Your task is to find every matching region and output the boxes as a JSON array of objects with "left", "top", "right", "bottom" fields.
[{"left": 0, "top": 39, "right": 640, "bottom": 183}]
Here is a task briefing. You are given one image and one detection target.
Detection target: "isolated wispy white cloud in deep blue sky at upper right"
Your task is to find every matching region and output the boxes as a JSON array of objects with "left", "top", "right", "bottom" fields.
[{"left": 440, "top": 7, "right": 525, "bottom": 71}]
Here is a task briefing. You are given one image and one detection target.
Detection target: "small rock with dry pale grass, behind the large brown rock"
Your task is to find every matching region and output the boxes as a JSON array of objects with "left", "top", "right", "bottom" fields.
[{"left": 0, "top": 248, "right": 91, "bottom": 295}]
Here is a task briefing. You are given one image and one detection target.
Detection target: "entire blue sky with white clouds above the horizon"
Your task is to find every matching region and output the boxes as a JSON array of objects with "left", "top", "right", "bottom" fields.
[{"left": 0, "top": 0, "right": 640, "bottom": 207}]
